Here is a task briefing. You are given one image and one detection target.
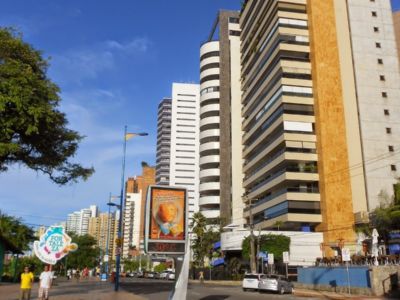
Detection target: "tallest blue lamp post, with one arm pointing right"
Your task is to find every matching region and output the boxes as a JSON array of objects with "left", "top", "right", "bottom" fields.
[{"left": 114, "top": 125, "right": 148, "bottom": 292}]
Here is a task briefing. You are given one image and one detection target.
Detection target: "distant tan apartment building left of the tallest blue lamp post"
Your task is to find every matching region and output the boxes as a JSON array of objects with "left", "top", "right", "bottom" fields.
[{"left": 88, "top": 213, "right": 119, "bottom": 260}]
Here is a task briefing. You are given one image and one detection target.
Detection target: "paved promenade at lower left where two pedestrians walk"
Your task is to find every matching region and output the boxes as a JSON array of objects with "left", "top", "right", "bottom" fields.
[{"left": 0, "top": 280, "right": 144, "bottom": 300}]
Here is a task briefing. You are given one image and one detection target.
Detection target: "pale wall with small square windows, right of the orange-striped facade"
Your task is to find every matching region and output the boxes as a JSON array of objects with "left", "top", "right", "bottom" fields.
[{"left": 347, "top": 0, "right": 400, "bottom": 210}]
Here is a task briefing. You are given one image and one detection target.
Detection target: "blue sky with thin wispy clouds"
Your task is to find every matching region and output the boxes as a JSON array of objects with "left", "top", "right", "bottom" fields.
[{"left": 0, "top": 0, "right": 400, "bottom": 225}]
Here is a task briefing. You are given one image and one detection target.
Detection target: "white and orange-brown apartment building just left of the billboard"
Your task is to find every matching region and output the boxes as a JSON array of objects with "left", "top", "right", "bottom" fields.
[{"left": 123, "top": 163, "right": 156, "bottom": 255}]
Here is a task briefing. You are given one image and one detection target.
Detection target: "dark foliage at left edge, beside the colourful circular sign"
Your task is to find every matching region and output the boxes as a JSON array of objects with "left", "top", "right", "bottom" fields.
[{"left": 0, "top": 211, "right": 35, "bottom": 251}]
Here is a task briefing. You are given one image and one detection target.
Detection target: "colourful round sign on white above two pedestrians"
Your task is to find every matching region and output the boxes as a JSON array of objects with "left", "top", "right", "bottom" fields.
[{"left": 33, "top": 226, "right": 78, "bottom": 265}]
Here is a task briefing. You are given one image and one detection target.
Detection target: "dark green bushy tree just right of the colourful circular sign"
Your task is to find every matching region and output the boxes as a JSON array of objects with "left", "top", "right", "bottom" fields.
[{"left": 63, "top": 234, "right": 100, "bottom": 269}]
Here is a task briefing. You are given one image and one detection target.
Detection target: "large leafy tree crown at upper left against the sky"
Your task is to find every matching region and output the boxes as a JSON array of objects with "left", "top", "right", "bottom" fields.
[{"left": 0, "top": 27, "right": 94, "bottom": 185}]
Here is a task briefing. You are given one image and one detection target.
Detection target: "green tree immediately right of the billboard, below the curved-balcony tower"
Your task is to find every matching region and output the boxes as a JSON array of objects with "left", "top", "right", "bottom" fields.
[{"left": 191, "top": 212, "right": 221, "bottom": 267}]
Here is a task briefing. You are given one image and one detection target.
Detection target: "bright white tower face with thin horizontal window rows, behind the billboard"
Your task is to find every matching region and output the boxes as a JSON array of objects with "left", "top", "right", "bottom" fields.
[{"left": 169, "top": 83, "right": 200, "bottom": 223}]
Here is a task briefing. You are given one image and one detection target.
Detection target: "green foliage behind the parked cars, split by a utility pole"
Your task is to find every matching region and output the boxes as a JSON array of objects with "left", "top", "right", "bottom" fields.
[{"left": 242, "top": 234, "right": 290, "bottom": 260}]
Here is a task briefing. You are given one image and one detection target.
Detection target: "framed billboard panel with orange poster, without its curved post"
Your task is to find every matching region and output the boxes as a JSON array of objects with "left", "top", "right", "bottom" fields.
[{"left": 145, "top": 186, "right": 187, "bottom": 254}]
